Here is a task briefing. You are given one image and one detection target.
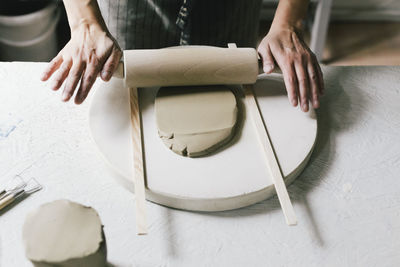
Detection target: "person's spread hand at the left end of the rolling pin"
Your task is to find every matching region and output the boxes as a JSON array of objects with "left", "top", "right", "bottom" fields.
[{"left": 41, "top": 21, "right": 122, "bottom": 104}]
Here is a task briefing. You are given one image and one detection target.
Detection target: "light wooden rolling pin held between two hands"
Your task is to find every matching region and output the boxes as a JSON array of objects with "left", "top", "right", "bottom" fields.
[{"left": 114, "top": 46, "right": 258, "bottom": 87}]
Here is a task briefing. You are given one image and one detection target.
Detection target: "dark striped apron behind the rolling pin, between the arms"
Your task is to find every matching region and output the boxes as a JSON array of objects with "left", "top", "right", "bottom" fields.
[{"left": 98, "top": 0, "right": 262, "bottom": 49}]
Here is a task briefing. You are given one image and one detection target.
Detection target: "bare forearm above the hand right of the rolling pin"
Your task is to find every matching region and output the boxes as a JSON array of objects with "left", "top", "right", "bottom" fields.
[{"left": 272, "top": 0, "right": 309, "bottom": 30}]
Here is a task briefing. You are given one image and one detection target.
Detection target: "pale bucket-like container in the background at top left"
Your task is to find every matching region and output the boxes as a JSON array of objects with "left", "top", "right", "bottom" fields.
[{"left": 0, "top": 0, "right": 60, "bottom": 61}]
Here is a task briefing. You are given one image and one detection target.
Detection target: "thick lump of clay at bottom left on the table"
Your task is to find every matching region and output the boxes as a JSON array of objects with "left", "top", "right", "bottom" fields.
[{"left": 22, "top": 200, "right": 107, "bottom": 267}]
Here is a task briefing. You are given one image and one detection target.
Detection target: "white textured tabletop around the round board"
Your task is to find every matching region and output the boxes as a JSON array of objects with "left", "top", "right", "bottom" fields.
[{"left": 0, "top": 63, "right": 400, "bottom": 267}]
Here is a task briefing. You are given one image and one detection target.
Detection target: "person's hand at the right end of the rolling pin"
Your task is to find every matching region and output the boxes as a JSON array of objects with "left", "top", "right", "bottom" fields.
[{"left": 257, "top": 25, "right": 324, "bottom": 112}]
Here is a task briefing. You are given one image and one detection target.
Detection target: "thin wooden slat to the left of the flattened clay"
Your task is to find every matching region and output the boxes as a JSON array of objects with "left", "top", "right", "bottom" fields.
[{"left": 129, "top": 88, "right": 147, "bottom": 235}]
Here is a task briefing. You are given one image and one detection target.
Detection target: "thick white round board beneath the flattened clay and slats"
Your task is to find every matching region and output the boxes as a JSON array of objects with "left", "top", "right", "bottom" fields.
[{"left": 89, "top": 74, "right": 317, "bottom": 211}]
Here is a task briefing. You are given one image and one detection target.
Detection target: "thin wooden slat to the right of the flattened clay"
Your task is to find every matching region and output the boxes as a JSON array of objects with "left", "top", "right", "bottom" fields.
[{"left": 244, "top": 85, "right": 297, "bottom": 225}]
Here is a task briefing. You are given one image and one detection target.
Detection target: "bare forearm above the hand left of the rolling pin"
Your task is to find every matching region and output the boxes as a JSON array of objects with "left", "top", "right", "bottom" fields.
[{"left": 64, "top": 0, "right": 107, "bottom": 32}]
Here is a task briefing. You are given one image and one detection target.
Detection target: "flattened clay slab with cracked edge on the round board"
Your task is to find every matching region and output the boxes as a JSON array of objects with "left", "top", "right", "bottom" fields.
[{"left": 155, "top": 85, "right": 238, "bottom": 157}]
